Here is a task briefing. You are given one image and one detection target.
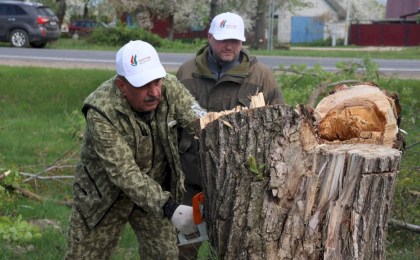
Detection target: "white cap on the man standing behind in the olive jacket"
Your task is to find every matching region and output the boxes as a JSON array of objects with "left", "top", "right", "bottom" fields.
[{"left": 209, "top": 12, "right": 245, "bottom": 42}]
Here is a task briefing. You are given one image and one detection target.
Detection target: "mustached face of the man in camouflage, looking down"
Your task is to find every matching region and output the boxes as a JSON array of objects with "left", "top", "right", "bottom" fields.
[{"left": 116, "top": 78, "right": 162, "bottom": 112}]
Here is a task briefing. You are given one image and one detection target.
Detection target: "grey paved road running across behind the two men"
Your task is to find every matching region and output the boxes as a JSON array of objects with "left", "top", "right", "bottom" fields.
[{"left": 0, "top": 47, "right": 420, "bottom": 78}]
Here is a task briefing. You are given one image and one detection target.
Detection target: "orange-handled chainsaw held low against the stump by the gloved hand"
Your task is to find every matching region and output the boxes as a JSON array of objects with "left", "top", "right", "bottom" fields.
[{"left": 178, "top": 192, "right": 208, "bottom": 246}]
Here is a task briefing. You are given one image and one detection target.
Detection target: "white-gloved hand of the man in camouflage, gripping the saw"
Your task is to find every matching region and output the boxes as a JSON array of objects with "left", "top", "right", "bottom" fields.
[{"left": 171, "top": 205, "right": 198, "bottom": 235}]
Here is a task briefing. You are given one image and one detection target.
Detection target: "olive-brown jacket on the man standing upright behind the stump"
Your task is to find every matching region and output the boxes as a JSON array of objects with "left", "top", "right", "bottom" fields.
[{"left": 176, "top": 46, "right": 284, "bottom": 112}]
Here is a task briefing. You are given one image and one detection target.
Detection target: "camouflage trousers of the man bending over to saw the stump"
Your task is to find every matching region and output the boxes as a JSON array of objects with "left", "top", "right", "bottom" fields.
[{"left": 65, "top": 195, "right": 178, "bottom": 260}]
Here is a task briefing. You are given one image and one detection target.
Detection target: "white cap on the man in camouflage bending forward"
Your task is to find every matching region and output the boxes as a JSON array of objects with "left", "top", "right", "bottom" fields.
[{"left": 115, "top": 40, "right": 166, "bottom": 88}]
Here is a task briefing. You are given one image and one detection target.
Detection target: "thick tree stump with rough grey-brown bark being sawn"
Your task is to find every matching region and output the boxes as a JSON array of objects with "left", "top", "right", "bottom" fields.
[{"left": 200, "top": 85, "right": 401, "bottom": 259}]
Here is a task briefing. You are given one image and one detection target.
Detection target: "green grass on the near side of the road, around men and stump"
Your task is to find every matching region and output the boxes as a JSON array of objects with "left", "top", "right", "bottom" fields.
[{"left": 0, "top": 60, "right": 420, "bottom": 259}]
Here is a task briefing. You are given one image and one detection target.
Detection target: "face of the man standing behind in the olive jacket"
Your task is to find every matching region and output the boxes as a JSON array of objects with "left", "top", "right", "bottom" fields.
[{"left": 207, "top": 33, "right": 242, "bottom": 62}]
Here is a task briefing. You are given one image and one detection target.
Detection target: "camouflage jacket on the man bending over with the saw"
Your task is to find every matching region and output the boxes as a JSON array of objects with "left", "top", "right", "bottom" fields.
[{"left": 73, "top": 74, "right": 205, "bottom": 228}]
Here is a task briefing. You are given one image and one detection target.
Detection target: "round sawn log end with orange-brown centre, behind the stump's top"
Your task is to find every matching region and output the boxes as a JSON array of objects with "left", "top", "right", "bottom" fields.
[{"left": 314, "top": 85, "right": 399, "bottom": 147}]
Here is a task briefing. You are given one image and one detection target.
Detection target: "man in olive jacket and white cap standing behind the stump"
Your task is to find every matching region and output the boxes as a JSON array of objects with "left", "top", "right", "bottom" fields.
[{"left": 176, "top": 12, "right": 284, "bottom": 258}]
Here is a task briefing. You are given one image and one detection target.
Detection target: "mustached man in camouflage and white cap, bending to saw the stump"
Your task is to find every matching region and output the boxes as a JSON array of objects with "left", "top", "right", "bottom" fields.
[{"left": 66, "top": 41, "right": 205, "bottom": 260}]
